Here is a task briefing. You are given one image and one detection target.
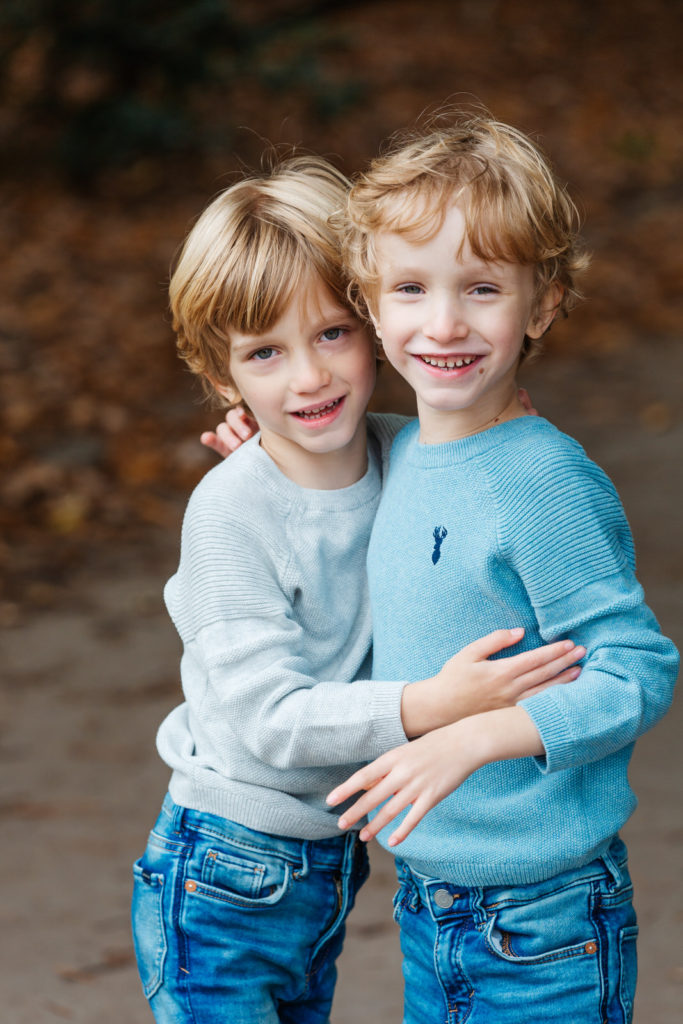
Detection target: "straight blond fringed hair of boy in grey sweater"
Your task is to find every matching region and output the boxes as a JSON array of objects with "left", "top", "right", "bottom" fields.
[{"left": 169, "top": 156, "right": 356, "bottom": 400}]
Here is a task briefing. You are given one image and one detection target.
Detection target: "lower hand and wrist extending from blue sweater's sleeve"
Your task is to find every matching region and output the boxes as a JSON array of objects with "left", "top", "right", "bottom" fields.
[{"left": 327, "top": 708, "right": 544, "bottom": 846}]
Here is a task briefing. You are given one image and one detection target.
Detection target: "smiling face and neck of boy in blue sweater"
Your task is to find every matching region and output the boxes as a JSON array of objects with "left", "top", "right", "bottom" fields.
[{"left": 376, "top": 205, "right": 552, "bottom": 443}]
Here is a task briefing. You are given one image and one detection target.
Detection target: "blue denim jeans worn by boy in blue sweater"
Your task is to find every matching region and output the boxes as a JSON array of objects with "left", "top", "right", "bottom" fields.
[{"left": 394, "top": 840, "right": 638, "bottom": 1024}]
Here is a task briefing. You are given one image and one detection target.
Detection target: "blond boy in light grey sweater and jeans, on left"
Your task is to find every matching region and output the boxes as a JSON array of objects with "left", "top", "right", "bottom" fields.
[{"left": 133, "top": 158, "right": 583, "bottom": 1024}]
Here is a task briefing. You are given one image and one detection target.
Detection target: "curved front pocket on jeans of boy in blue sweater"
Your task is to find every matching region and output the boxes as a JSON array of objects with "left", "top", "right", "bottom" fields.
[{"left": 485, "top": 884, "right": 598, "bottom": 965}]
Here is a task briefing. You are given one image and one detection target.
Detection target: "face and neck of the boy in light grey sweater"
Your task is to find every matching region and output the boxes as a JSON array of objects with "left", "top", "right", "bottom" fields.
[{"left": 220, "top": 278, "right": 376, "bottom": 489}]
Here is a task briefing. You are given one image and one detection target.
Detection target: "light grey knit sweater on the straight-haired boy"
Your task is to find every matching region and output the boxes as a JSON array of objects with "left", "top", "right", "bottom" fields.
[{"left": 157, "top": 414, "right": 405, "bottom": 839}]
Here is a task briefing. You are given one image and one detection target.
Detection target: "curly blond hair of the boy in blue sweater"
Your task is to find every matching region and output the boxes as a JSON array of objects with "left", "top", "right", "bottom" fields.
[{"left": 343, "top": 115, "right": 590, "bottom": 356}]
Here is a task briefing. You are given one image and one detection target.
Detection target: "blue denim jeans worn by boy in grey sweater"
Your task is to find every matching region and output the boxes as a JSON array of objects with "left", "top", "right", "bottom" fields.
[{"left": 132, "top": 797, "right": 368, "bottom": 1024}]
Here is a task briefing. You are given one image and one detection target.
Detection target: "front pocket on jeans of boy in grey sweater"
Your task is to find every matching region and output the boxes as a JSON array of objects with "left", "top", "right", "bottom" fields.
[{"left": 191, "top": 847, "right": 292, "bottom": 908}]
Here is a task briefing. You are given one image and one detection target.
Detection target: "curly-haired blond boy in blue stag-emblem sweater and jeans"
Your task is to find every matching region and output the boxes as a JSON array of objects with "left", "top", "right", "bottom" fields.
[{"left": 329, "top": 117, "right": 678, "bottom": 1024}]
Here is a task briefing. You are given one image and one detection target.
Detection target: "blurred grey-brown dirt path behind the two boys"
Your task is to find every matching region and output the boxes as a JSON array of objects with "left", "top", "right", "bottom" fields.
[{"left": 0, "top": 345, "right": 683, "bottom": 1024}]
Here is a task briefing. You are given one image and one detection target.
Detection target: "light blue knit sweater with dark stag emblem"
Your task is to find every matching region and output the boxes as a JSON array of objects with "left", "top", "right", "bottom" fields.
[{"left": 368, "top": 417, "right": 678, "bottom": 886}]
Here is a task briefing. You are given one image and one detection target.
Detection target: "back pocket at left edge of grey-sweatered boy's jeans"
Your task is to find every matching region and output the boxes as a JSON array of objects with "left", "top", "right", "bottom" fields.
[{"left": 132, "top": 860, "right": 168, "bottom": 998}]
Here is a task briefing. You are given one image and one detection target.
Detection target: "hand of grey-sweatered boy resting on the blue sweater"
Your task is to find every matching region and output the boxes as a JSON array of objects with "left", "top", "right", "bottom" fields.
[{"left": 401, "top": 629, "right": 586, "bottom": 737}]
